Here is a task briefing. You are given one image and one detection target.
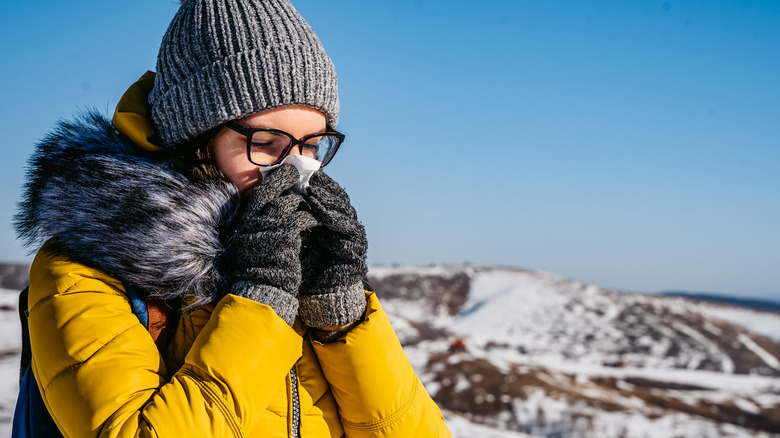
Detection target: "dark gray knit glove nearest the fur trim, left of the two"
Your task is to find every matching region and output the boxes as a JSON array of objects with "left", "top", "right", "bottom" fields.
[{"left": 230, "top": 165, "right": 318, "bottom": 326}]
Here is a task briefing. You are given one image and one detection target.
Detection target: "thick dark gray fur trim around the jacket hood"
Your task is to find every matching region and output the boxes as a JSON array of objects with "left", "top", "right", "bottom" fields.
[{"left": 14, "top": 111, "right": 240, "bottom": 306}]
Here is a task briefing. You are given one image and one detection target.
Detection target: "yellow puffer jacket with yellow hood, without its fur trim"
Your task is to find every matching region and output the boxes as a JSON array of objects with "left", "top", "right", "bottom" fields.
[{"left": 28, "top": 75, "right": 451, "bottom": 438}]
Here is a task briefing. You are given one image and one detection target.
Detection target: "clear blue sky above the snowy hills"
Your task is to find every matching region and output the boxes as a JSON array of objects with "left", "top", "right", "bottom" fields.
[{"left": 0, "top": 0, "right": 780, "bottom": 299}]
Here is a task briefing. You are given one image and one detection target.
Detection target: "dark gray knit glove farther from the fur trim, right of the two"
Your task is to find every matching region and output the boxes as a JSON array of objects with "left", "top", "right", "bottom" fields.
[{"left": 298, "top": 171, "right": 368, "bottom": 328}]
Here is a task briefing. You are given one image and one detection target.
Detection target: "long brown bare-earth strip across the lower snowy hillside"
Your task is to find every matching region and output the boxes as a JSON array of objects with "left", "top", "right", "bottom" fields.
[{"left": 425, "top": 353, "right": 780, "bottom": 432}]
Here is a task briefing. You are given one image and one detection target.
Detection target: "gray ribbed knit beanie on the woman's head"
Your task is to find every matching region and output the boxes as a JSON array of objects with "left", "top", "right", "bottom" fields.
[{"left": 149, "top": 0, "right": 339, "bottom": 147}]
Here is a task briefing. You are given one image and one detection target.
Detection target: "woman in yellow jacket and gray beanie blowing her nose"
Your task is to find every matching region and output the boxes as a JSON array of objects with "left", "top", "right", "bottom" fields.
[{"left": 17, "top": 0, "right": 451, "bottom": 438}]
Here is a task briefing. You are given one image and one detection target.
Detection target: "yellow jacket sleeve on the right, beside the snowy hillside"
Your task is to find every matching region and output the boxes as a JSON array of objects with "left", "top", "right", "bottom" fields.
[{"left": 312, "top": 292, "right": 452, "bottom": 438}]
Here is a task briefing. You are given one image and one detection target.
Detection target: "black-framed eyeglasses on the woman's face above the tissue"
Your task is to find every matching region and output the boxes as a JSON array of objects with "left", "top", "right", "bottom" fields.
[{"left": 225, "top": 122, "right": 344, "bottom": 167}]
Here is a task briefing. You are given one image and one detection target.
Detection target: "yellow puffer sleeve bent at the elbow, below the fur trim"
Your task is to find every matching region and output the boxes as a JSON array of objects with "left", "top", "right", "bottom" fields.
[{"left": 29, "top": 253, "right": 302, "bottom": 437}]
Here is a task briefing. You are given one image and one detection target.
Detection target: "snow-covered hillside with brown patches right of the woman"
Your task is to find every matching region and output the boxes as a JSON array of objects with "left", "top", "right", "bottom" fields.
[{"left": 369, "top": 267, "right": 780, "bottom": 438}]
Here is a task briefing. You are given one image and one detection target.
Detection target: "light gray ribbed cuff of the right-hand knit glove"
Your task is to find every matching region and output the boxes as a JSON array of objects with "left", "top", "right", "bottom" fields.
[{"left": 298, "top": 282, "right": 366, "bottom": 328}]
